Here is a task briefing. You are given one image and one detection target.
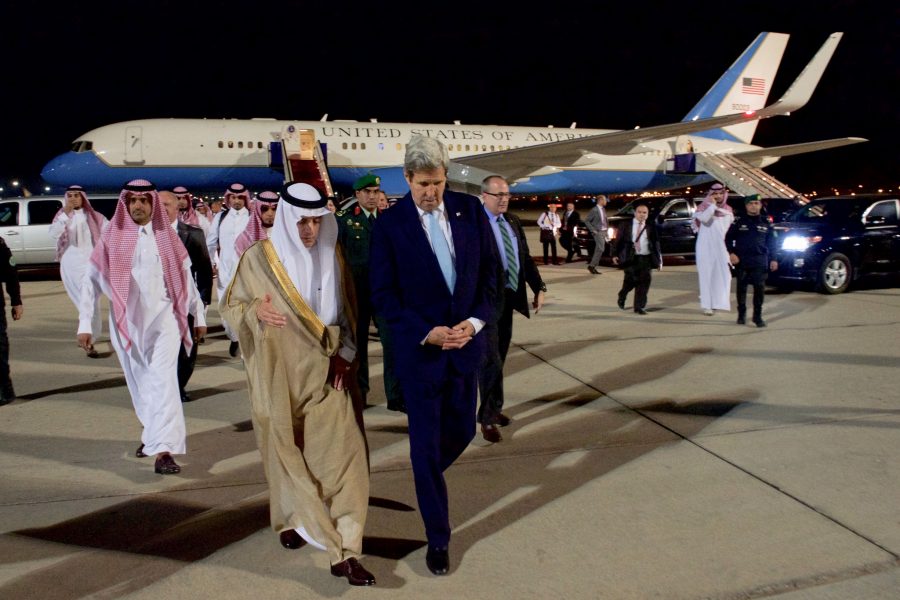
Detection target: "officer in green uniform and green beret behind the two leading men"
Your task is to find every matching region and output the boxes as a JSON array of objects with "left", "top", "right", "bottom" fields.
[{"left": 335, "top": 173, "right": 406, "bottom": 412}]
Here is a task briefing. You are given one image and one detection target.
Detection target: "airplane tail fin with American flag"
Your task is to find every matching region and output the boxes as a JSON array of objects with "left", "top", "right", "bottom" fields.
[{"left": 682, "top": 32, "right": 790, "bottom": 144}]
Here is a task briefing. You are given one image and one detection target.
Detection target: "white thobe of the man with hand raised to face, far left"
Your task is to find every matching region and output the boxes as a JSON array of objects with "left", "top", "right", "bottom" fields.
[{"left": 50, "top": 210, "right": 107, "bottom": 338}]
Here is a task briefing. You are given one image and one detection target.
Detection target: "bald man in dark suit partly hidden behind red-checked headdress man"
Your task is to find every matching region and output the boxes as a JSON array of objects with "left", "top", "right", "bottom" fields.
[{"left": 159, "top": 191, "right": 213, "bottom": 402}]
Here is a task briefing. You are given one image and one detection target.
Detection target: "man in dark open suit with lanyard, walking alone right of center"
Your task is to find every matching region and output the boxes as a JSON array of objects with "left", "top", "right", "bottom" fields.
[{"left": 613, "top": 204, "right": 662, "bottom": 315}]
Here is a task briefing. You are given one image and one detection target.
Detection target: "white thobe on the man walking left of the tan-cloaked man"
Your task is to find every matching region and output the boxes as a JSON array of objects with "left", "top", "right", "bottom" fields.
[{"left": 78, "top": 224, "right": 206, "bottom": 456}]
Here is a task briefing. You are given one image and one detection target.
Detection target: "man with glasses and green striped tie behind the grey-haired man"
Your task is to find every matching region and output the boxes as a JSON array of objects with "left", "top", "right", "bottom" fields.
[{"left": 478, "top": 175, "right": 547, "bottom": 443}]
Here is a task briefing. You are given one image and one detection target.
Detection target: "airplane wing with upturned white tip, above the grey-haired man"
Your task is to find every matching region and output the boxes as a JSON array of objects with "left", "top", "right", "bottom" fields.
[{"left": 454, "top": 33, "right": 843, "bottom": 179}]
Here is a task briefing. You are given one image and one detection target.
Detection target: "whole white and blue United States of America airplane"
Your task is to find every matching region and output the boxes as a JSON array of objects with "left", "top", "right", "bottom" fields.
[{"left": 41, "top": 32, "right": 867, "bottom": 195}]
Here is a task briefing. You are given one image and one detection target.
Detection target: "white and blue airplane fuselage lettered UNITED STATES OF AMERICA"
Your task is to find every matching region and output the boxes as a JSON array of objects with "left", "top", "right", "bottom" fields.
[{"left": 42, "top": 119, "right": 774, "bottom": 195}]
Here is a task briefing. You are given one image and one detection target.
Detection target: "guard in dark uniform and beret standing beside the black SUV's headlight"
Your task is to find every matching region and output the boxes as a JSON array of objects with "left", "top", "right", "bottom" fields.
[{"left": 725, "top": 194, "right": 778, "bottom": 327}]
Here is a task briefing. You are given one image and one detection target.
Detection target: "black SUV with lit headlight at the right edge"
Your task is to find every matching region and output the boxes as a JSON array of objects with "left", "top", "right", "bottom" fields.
[{"left": 769, "top": 194, "right": 900, "bottom": 294}]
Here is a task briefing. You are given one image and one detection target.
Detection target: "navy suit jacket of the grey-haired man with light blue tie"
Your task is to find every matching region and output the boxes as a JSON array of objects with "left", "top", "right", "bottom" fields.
[{"left": 369, "top": 191, "right": 497, "bottom": 382}]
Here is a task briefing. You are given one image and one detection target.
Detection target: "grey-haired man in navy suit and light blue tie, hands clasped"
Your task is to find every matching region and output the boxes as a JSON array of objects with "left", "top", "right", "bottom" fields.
[{"left": 369, "top": 135, "right": 497, "bottom": 575}]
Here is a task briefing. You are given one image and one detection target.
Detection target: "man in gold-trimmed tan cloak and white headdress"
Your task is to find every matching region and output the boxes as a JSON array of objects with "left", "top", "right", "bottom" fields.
[{"left": 222, "top": 183, "right": 375, "bottom": 585}]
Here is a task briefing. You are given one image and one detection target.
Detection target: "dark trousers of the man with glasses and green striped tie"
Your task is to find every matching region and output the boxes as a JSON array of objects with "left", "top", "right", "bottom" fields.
[{"left": 478, "top": 288, "right": 516, "bottom": 425}]
